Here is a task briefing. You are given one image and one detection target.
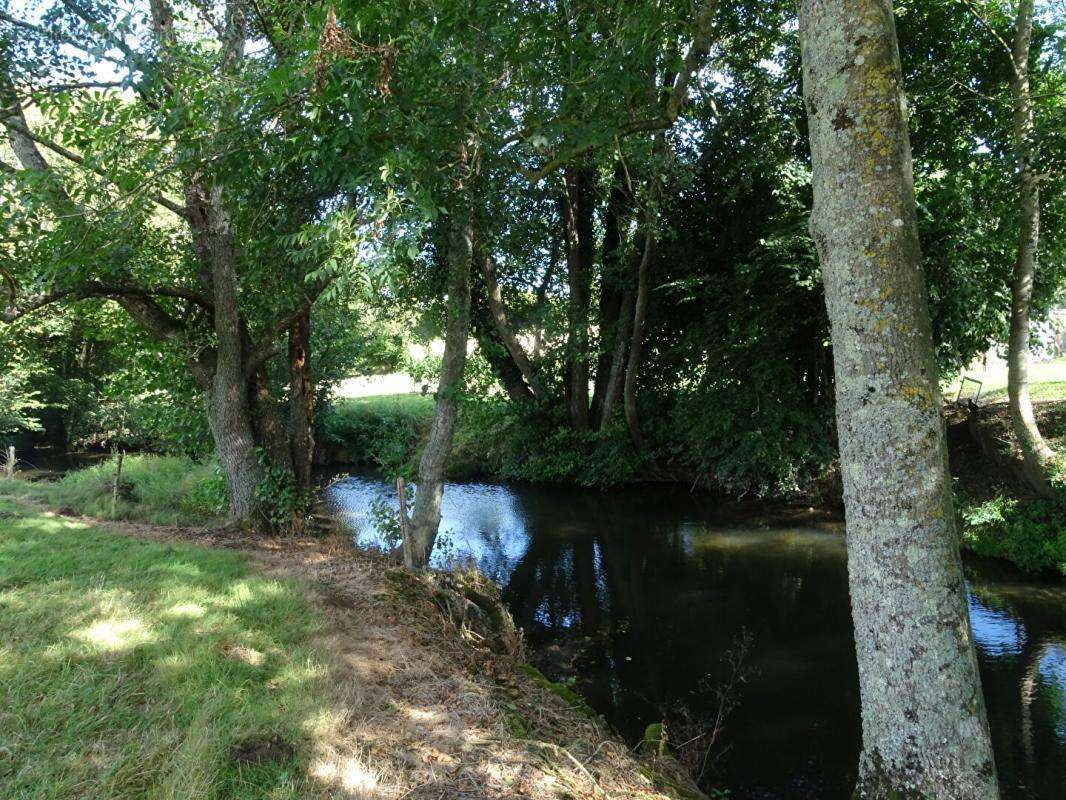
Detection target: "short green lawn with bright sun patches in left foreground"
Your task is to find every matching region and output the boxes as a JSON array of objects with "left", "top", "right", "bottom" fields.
[{"left": 0, "top": 498, "right": 326, "bottom": 800}]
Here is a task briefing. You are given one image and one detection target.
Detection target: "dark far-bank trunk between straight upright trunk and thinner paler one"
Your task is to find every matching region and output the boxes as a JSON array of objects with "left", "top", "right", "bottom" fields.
[{"left": 592, "top": 162, "right": 632, "bottom": 430}]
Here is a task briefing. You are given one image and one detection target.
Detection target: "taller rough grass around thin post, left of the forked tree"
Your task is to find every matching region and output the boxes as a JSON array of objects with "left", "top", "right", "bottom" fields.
[{"left": 0, "top": 455, "right": 226, "bottom": 525}]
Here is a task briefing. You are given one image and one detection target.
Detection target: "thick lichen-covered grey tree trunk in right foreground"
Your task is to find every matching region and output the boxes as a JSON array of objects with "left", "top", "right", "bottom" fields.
[{"left": 800, "top": 0, "right": 999, "bottom": 800}]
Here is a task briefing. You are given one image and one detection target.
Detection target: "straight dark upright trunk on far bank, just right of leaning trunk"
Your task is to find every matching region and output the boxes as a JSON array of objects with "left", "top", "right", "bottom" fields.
[{"left": 563, "top": 169, "right": 593, "bottom": 431}]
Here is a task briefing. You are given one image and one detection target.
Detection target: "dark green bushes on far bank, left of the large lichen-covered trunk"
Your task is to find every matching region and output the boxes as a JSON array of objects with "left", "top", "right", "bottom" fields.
[{"left": 318, "top": 391, "right": 831, "bottom": 496}]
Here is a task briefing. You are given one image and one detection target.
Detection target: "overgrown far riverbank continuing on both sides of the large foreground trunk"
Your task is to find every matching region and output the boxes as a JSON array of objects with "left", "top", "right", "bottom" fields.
[{"left": 320, "top": 392, "right": 1066, "bottom": 576}]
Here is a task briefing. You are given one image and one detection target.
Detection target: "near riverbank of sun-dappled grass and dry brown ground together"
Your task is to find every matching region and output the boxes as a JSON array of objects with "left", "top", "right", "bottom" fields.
[{"left": 0, "top": 493, "right": 707, "bottom": 800}]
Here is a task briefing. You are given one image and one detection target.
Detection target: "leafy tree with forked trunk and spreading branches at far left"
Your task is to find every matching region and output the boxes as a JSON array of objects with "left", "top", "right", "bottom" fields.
[{"left": 0, "top": 0, "right": 362, "bottom": 521}]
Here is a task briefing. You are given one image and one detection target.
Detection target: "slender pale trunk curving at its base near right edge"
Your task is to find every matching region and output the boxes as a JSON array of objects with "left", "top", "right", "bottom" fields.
[{"left": 1007, "top": 0, "right": 1054, "bottom": 496}]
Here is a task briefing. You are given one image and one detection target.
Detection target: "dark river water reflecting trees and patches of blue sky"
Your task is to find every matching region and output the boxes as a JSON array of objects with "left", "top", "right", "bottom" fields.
[{"left": 327, "top": 475, "right": 1066, "bottom": 800}]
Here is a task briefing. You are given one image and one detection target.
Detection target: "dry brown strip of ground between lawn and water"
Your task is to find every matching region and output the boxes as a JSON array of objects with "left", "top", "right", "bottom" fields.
[{"left": 25, "top": 503, "right": 701, "bottom": 800}]
